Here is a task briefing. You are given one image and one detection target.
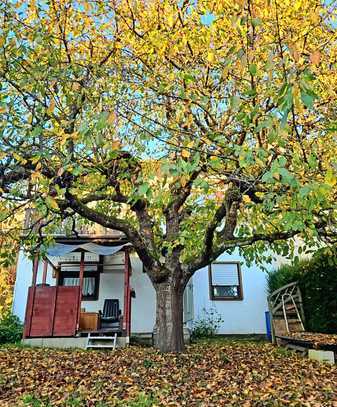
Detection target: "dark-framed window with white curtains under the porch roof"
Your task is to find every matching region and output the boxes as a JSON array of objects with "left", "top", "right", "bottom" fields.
[{"left": 59, "top": 263, "right": 100, "bottom": 301}]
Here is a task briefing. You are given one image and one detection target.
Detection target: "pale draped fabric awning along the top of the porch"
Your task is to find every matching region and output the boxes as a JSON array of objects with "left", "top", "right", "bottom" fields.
[{"left": 47, "top": 243, "right": 131, "bottom": 256}]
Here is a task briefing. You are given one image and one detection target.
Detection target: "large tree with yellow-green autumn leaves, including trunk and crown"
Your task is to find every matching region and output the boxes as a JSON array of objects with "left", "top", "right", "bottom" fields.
[{"left": 0, "top": 0, "right": 337, "bottom": 351}]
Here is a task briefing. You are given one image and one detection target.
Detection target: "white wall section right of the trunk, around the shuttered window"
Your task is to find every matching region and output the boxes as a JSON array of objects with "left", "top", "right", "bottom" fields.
[{"left": 193, "top": 253, "right": 268, "bottom": 334}]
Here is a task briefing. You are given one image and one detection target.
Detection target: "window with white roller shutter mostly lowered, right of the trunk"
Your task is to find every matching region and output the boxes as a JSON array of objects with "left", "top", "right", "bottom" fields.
[{"left": 209, "top": 262, "right": 243, "bottom": 300}]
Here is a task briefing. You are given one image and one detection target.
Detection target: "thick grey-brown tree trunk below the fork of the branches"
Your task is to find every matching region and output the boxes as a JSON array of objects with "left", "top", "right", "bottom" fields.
[{"left": 155, "top": 281, "right": 185, "bottom": 352}]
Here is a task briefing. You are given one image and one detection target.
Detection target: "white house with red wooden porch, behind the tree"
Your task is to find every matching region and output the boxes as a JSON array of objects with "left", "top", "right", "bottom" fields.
[{"left": 13, "top": 231, "right": 267, "bottom": 346}]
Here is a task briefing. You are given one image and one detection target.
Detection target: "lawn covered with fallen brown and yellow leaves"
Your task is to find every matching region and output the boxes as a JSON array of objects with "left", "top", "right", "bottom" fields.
[{"left": 0, "top": 341, "right": 337, "bottom": 407}]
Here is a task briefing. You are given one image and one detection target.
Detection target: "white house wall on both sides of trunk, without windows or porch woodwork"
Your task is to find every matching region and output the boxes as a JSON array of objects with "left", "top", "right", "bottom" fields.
[{"left": 13, "top": 247, "right": 268, "bottom": 334}]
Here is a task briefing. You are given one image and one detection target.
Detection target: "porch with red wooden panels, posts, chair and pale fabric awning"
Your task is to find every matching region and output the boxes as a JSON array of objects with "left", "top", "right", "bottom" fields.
[{"left": 24, "top": 243, "right": 133, "bottom": 347}]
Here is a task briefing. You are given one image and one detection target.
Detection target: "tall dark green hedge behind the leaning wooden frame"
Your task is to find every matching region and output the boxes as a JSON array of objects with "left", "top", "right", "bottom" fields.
[{"left": 268, "top": 248, "right": 337, "bottom": 333}]
